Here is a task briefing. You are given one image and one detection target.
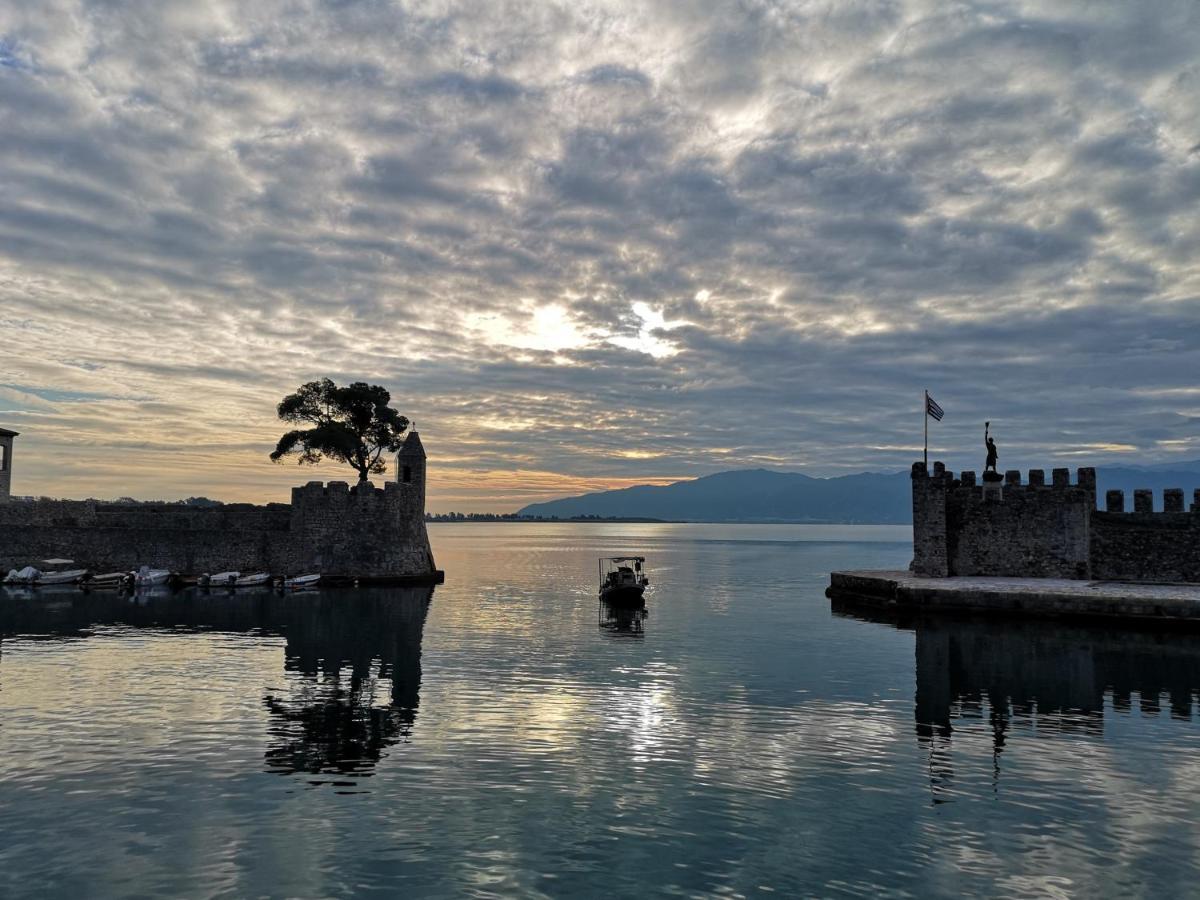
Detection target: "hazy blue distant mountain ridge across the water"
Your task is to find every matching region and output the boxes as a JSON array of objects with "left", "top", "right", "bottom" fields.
[{"left": 518, "top": 460, "right": 1200, "bottom": 524}]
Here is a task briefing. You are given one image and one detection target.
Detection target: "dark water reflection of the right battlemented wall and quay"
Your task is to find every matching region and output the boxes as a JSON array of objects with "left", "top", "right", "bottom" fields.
[{"left": 834, "top": 600, "right": 1200, "bottom": 802}]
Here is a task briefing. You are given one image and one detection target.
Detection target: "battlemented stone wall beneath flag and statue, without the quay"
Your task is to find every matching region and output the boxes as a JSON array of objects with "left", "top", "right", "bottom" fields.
[{"left": 912, "top": 462, "right": 1200, "bottom": 582}]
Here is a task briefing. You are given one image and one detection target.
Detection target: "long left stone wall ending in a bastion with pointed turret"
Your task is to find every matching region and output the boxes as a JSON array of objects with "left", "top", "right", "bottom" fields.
[{"left": 0, "top": 432, "right": 440, "bottom": 582}]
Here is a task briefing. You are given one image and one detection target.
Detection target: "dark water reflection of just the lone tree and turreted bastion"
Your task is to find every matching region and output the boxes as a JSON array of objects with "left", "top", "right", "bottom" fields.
[{"left": 263, "top": 588, "right": 432, "bottom": 778}]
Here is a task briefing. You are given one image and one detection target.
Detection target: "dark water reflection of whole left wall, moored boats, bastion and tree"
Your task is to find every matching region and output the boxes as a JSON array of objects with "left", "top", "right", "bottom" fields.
[{"left": 0, "top": 587, "right": 433, "bottom": 782}]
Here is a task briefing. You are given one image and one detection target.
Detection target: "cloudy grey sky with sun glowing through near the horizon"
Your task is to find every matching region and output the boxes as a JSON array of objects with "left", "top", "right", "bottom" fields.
[{"left": 0, "top": 0, "right": 1200, "bottom": 511}]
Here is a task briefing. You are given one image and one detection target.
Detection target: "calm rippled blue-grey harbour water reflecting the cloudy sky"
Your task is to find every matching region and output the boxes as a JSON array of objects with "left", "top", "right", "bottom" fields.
[{"left": 0, "top": 524, "right": 1200, "bottom": 898}]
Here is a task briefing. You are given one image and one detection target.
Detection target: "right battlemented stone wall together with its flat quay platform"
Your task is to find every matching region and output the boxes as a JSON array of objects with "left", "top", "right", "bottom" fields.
[{"left": 826, "top": 462, "right": 1200, "bottom": 625}]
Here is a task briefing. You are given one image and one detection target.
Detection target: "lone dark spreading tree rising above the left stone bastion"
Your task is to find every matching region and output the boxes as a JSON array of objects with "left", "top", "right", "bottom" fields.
[{"left": 271, "top": 378, "right": 408, "bottom": 484}]
